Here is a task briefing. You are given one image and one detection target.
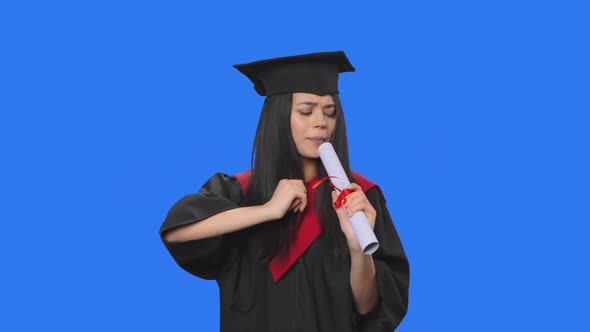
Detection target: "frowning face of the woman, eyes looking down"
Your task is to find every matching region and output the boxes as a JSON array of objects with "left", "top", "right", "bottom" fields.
[{"left": 291, "top": 92, "right": 336, "bottom": 158}]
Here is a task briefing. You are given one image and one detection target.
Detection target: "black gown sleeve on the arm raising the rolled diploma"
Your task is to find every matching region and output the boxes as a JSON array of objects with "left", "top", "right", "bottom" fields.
[{"left": 357, "top": 188, "right": 410, "bottom": 332}]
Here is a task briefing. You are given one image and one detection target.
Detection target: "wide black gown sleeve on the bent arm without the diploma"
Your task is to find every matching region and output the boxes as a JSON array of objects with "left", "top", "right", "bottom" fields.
[{"left": 160, "top": 173, "right": 242, "bottom": 280}]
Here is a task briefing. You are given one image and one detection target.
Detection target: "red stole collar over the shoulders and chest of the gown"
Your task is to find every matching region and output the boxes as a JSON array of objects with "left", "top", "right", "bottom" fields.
[{"left": 235, "top": 171, "right": 383, "bottom": 282}]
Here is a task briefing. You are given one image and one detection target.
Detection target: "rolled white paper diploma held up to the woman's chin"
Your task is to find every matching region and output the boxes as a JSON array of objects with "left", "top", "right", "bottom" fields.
[{"left": 319, "top": 143, "right": 379, "bottom": 255}]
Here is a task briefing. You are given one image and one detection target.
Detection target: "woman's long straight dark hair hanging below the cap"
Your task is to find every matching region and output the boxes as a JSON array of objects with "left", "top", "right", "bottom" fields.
[{"left": 245, "top": 93, "right": 354, "bottom": 262}]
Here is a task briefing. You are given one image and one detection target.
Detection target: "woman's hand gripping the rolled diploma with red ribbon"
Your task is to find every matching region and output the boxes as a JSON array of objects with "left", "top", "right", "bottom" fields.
[{"left": 332, "top": 183, "right": 377, "bottom": 253}]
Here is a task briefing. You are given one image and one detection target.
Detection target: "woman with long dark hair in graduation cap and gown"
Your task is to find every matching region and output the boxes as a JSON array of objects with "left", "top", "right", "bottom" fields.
[{"left": 160, "top": 52, "right": 409, "bottom": 332}]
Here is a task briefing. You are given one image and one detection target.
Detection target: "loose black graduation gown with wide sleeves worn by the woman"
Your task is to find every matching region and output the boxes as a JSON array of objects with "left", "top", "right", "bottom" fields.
[{"left": 160, "top": 173, "right": 409, "bottom": 332}]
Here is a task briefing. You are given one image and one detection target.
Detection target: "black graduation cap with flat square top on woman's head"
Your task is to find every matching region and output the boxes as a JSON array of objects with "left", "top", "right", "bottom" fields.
[{"left": 234, "top": 51, "right": 355, "bottom": 96}]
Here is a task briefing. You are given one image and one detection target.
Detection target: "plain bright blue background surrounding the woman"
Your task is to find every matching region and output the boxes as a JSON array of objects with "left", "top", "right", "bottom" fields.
[{"left": 0, "top": 1, "right": 590, "bottom": 331}]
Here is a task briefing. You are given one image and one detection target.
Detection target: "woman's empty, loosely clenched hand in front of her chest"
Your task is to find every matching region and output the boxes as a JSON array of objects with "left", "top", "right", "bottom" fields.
[{"left": 264, "top": 179, "right": 307, "bottom": 219}]
